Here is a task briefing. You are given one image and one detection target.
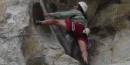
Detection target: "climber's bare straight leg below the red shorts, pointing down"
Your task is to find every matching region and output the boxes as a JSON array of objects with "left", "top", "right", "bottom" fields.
[{"left": 78, "top": 39, "right": 88, "bottom": 63}]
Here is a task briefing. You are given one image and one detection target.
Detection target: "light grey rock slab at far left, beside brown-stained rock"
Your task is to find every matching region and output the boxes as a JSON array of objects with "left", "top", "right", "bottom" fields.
[{"left": 0, "top": 0, "right": 29, "bottom": 65}]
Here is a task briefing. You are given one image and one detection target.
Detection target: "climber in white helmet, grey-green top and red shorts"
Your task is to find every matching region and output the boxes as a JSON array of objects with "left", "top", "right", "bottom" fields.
[{"left": 35, "top": 1, "right": 90, "bottom": 64}]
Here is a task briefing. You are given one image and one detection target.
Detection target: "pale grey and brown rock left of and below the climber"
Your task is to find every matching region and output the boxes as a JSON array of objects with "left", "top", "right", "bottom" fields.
[{"left": 0, "top": 0, "right": 80, "bottom": 65}]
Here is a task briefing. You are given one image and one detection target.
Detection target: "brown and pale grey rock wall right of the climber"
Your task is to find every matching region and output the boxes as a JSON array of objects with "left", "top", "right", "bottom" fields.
[{"left": 91, "top": 0, "right": 130, "bottom": 65}]
